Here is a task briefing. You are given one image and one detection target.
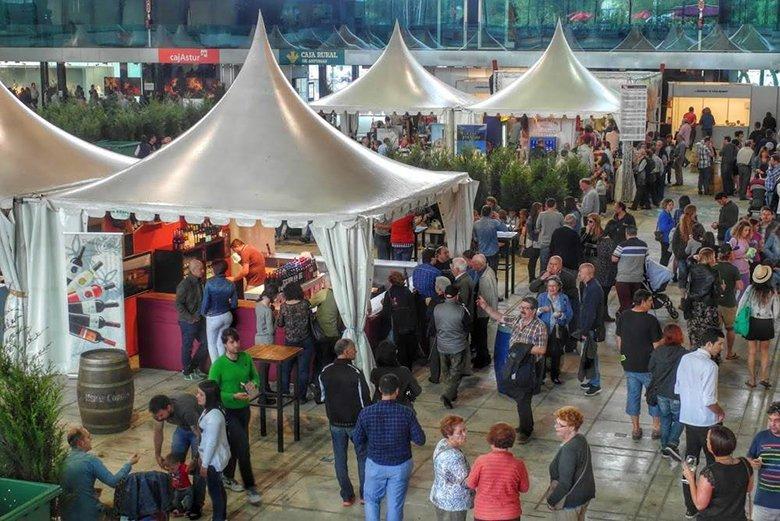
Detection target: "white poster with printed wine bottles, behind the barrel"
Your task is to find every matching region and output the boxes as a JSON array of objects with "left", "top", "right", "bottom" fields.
[{"left": 65, "top": 233, "right": 125, "bottom": 371}]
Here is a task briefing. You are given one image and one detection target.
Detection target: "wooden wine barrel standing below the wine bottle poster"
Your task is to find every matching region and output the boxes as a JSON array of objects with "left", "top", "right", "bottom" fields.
[{"left": 76, "top": 349, "right": 135, "bottom": 434}]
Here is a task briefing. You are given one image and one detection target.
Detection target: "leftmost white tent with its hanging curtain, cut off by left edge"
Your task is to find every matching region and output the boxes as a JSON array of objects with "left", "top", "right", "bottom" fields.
[{"left": 0, "top": 85, "right": 135, "bottom": 356}]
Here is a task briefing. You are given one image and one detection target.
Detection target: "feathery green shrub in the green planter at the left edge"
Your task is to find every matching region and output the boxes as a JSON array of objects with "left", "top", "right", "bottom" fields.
[{"left": 0, "top": 335, "right": 67, "bottom": 483}]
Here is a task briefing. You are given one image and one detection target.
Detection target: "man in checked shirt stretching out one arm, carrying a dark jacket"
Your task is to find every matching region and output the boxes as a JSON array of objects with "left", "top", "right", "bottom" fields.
[{"left": 477, "top": 296, "right": 547, "bottom": 444}]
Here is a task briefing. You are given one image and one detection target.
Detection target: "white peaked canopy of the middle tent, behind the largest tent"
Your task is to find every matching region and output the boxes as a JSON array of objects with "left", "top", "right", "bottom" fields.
[{"left": 310, "top": 23, "right": 475, "bottom": 112}]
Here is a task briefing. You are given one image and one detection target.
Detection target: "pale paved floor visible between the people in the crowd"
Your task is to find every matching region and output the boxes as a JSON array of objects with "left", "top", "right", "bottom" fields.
[{"left": 64, "top": 170, "right": 780, "bottom": 521}]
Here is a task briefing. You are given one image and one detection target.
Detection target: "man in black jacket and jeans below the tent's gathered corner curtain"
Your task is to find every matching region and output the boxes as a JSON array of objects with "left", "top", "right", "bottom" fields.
[{"left": 319, "top": 338, "right": 371, "bottom": 507}]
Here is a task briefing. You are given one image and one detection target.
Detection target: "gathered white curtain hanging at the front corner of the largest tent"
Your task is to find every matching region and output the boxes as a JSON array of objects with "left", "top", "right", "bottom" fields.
[{"left": 312, "top": 217, "right": 375, "bottom": 376}]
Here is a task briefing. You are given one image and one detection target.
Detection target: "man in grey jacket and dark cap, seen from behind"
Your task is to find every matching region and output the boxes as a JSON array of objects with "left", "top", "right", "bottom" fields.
[{"left": 430, "top": 284, "right": 471, "bottom": 409}]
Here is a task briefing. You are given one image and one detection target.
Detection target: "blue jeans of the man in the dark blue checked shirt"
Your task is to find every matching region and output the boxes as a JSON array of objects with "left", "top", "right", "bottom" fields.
[{"left": 363, "top": 458, "right": 414, "bottom": 521}]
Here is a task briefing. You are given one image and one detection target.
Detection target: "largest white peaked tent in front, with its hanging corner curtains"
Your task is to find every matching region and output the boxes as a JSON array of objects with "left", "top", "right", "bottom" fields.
[{"left": 50, "top": 15, "right": 476, "bottom": 374}]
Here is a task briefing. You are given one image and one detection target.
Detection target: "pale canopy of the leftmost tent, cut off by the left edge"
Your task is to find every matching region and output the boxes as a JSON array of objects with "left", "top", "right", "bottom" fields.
[{"left": 0, "top": 81, "right": 136, "bottom": 208}]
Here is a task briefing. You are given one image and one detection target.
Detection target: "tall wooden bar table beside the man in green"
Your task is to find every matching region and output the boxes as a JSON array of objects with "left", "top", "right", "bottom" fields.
[{"left": 246, "top": 344, "right": 303, "bottom": 452}]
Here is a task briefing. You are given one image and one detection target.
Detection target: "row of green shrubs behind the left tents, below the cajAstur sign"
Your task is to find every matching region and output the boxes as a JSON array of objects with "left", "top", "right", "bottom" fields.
[{"left": 39, "top": 96, "right": 213, "bottom": 142}]
